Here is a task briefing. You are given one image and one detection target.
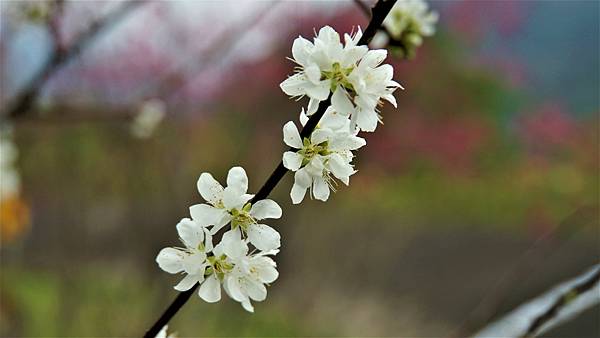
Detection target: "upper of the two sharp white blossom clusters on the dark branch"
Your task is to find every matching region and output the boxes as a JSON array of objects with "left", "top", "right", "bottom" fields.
[{"left": 281, "top": 26, "right": 401, "bottom": 204}]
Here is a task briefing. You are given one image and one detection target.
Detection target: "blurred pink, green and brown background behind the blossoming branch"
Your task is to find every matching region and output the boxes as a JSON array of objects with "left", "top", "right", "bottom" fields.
[{"left": 0, "top": 0, "right": 600, "bottom": 337}]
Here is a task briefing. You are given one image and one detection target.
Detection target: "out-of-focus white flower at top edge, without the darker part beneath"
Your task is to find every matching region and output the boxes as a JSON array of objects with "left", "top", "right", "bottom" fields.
[{"left": 383, "top": 0, "right": 439, "bottom": 39}]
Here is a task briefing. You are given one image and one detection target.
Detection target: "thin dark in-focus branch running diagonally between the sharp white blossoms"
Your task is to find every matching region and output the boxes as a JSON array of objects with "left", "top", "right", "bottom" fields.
[{"left": 144, "top": 0, "right": 396, "bottom": 338}]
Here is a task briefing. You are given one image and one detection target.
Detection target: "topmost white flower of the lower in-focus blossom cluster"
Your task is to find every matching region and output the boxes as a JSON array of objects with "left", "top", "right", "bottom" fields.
[{"left": 190, "top": 167, "right": 282, "bottom": 250}]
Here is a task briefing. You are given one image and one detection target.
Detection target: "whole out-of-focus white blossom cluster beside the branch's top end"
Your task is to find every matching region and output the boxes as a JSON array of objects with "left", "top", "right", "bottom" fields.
[{"left": 373, "top": 0, "right": 439, "bottom": 58}]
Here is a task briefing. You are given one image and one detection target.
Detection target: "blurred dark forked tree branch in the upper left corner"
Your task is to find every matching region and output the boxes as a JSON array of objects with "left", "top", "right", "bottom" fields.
[{"left": 3, "top": 0, "right": 146, "bottom": 119}]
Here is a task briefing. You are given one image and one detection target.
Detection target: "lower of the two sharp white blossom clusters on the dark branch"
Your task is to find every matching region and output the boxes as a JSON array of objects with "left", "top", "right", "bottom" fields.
[{"left": 156, "top": 167, "right": 282, "bottom": 312}]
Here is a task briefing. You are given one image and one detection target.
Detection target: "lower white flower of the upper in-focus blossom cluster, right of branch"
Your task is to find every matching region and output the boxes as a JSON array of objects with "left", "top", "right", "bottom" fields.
[{"left": 283, "top": 107, "right": 366, "bottom": 204}]
